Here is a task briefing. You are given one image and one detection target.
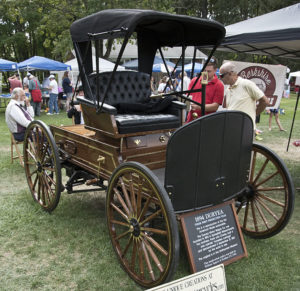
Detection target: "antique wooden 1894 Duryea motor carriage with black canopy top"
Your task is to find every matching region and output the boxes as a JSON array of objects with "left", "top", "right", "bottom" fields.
[{"left": 24, "top": 10, "right": 294, "bottom": 288}]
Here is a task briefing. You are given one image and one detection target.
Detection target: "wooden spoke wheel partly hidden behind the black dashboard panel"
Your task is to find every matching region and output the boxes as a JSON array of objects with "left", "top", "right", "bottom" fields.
[{"left": 236, "top": 144, "right": 295, "bottom": 238}]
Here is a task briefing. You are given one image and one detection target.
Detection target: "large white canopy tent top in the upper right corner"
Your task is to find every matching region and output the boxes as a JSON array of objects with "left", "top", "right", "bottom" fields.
[{"left": 214, "top": 3, "right": 300, "bottom": 59}]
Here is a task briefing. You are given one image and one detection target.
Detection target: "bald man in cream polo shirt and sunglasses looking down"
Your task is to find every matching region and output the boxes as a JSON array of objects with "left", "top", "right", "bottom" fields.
[{"left": 220, "top": 62, "right": 269, "bottom": 136}]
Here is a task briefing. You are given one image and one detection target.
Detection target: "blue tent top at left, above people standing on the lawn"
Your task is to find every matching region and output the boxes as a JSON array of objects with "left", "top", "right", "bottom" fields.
[{"left": 18, "top": 56, "right": 71, "bottom": 71}]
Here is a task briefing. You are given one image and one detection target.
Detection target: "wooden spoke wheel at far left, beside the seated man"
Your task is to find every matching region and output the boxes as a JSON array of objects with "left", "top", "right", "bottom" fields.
[{"left": 24, "top": 121, "right": 61, "bottom": 212}]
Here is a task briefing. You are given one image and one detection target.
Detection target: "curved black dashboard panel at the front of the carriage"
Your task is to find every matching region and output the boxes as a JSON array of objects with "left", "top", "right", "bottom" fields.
[{"left": 165, "top": 111, "right": 253, "bottom": 212}]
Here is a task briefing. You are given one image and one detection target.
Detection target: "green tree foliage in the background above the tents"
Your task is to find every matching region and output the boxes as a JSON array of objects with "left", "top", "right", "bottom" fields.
[{"left": 0, "top": 0, "right": 298, "bottom": 69}]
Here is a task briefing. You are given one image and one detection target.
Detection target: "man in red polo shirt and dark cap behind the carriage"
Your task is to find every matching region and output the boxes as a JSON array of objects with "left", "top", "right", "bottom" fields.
[{"left": 187, "top": 57, "right": 224, "bottom": 122}]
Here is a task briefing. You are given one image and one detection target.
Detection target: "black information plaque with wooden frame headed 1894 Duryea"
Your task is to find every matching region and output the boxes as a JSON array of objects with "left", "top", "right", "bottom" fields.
[{"left": 180, "top": 200, "right": 247, "bottom": 273}]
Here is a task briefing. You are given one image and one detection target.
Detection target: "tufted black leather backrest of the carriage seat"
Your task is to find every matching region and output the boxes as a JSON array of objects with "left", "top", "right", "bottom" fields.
[{"left": 85, "top": 71, "right": 151, "bottom": 106}]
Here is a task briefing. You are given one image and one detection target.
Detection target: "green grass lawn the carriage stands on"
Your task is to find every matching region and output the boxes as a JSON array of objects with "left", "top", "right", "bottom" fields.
[{"left": 0, "top": 95, "right": 300, "bottom": 291}]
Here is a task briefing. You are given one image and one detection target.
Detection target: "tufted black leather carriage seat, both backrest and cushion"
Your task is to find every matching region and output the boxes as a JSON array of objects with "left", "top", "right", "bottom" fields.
[{"left": 85, "top": 71, "right": 185, "bottom": 134}]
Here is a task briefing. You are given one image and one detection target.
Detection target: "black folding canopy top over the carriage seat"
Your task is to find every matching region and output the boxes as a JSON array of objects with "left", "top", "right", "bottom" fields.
[{"left": 71, "top": 9, "right": 225, "bottom": 74}]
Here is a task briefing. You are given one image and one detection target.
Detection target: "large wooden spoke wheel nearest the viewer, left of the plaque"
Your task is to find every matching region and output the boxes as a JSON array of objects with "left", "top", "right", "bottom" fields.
[{"left": 106, "top": 162, "right": 179, "bottom": 288}]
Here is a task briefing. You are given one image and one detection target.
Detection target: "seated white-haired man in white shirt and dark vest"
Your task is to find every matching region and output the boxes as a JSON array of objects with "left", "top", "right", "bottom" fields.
[{"left": 5, "top": 88, "right": 34, "bottom": 141}]
